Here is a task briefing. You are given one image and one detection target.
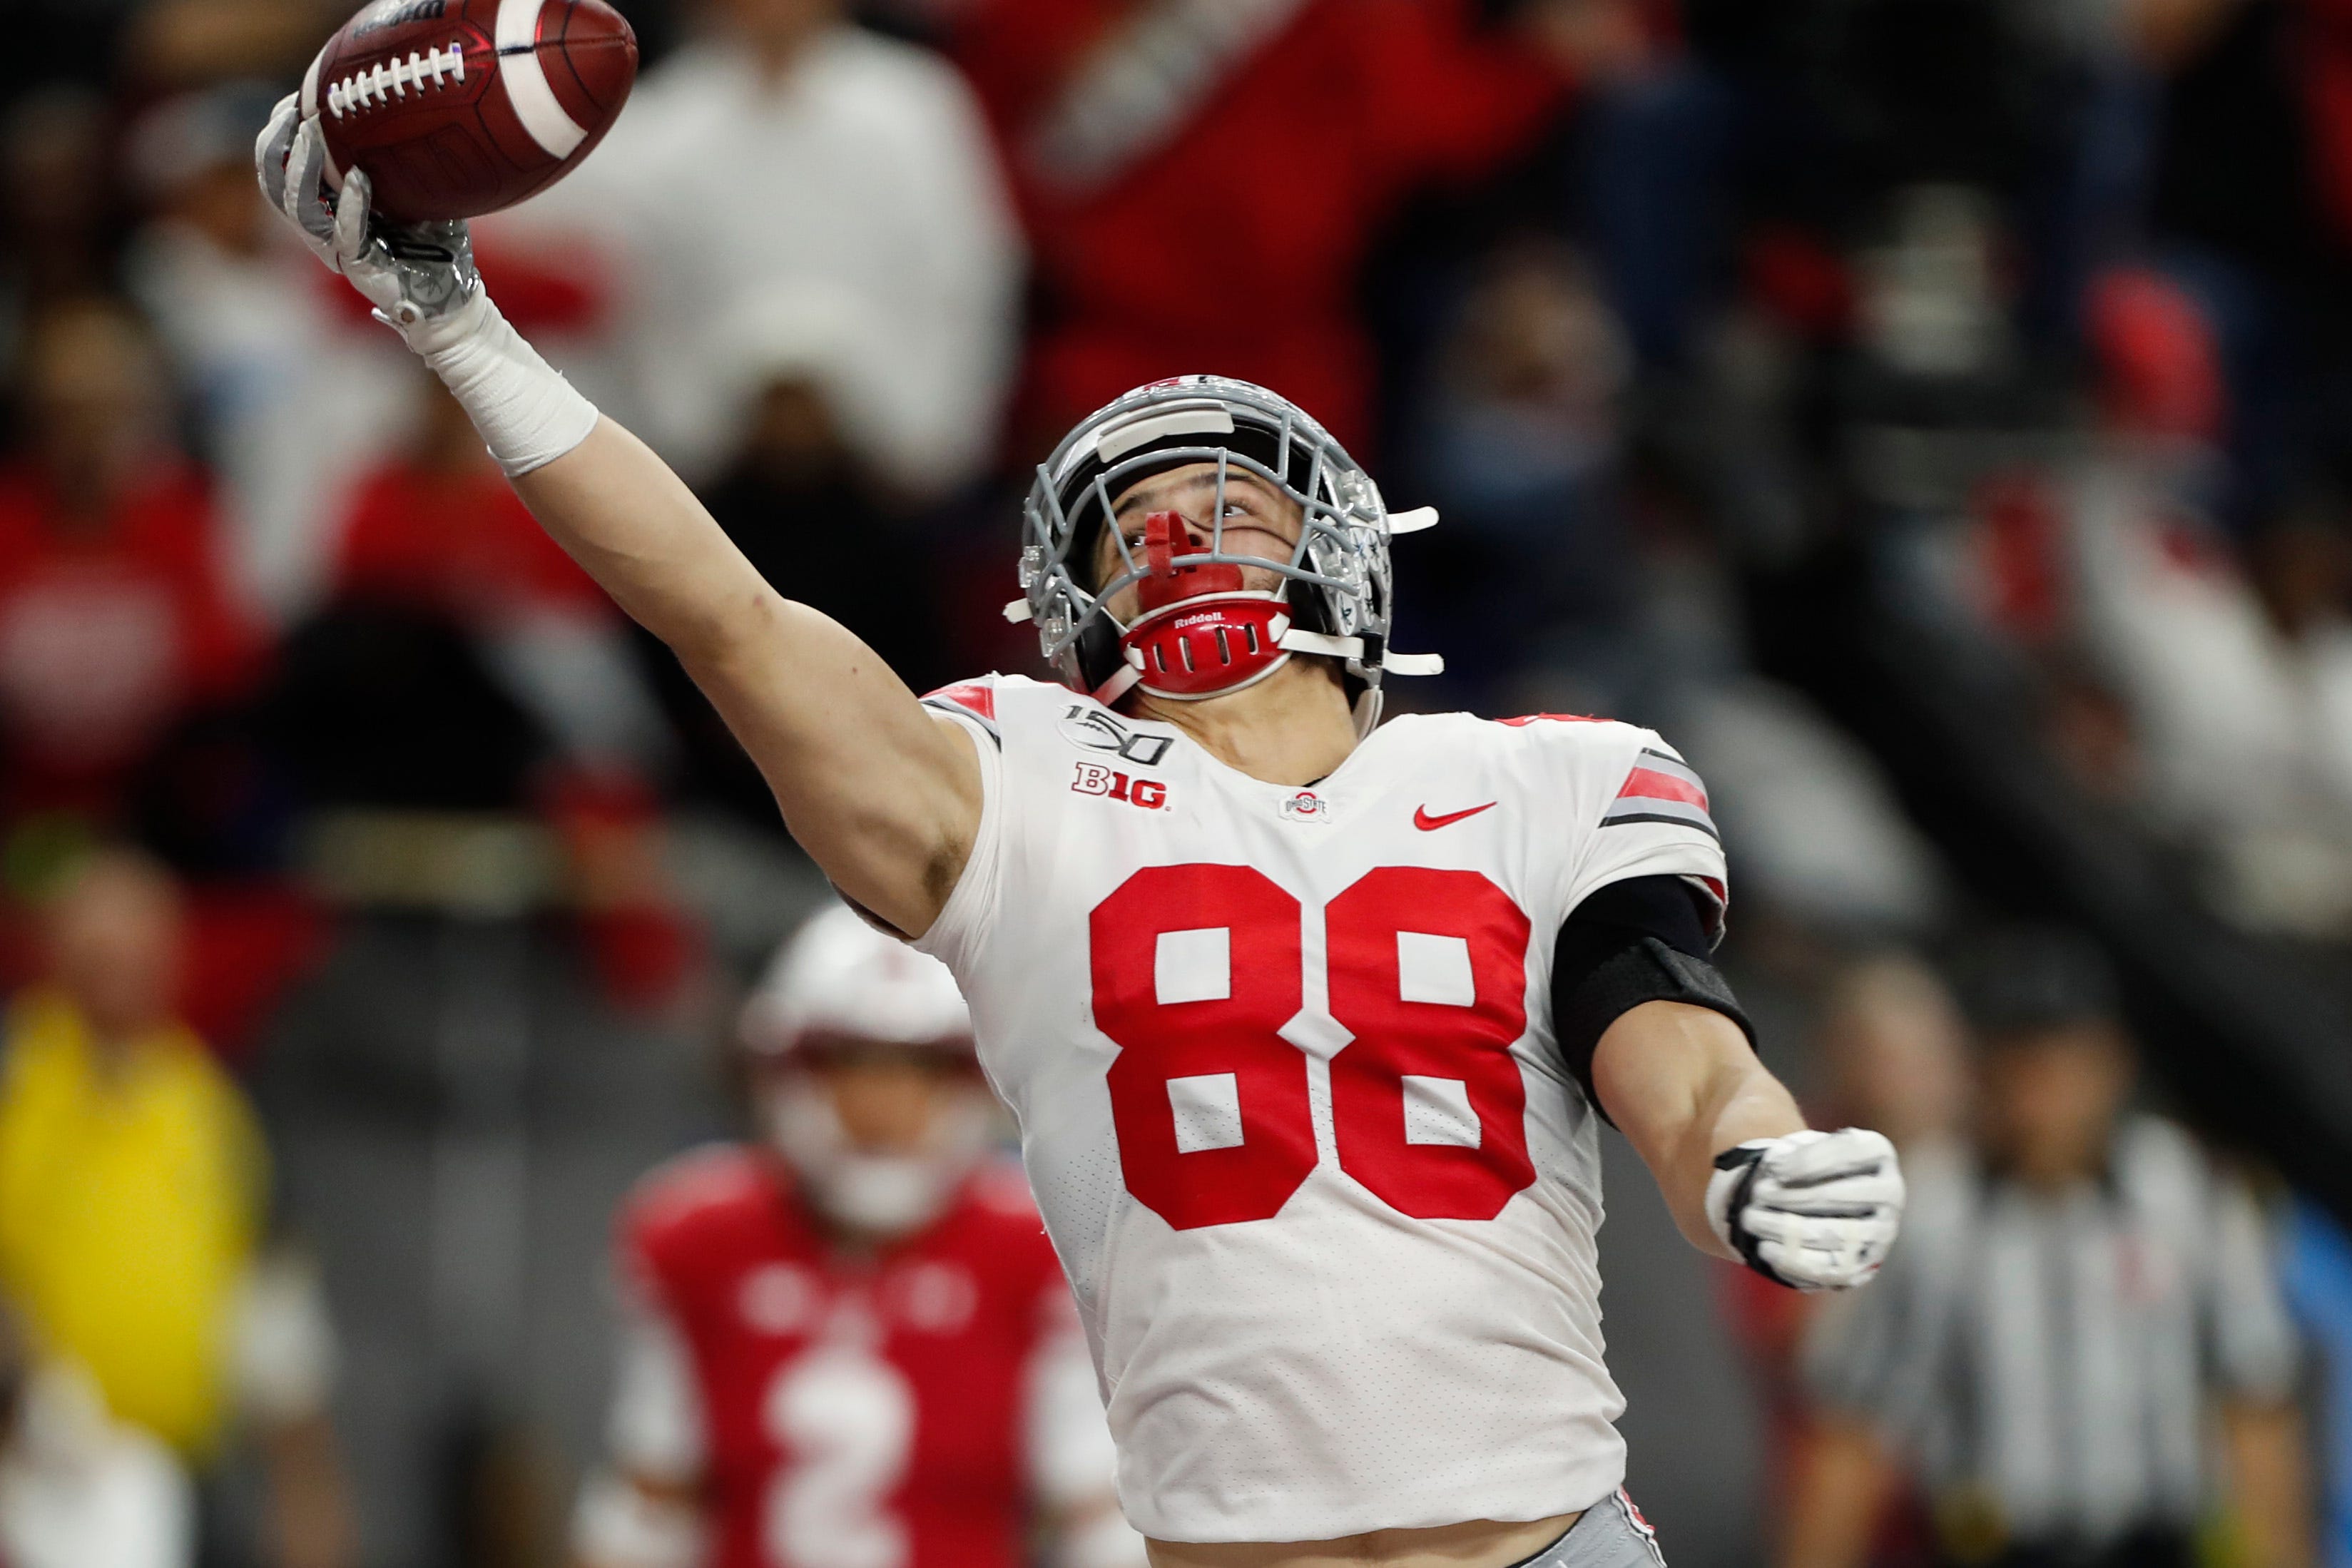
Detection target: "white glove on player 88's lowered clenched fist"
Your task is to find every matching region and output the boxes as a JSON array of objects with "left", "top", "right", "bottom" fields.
[{"left": 1708, "top": 1126, "right": 1903, "bottom": 1290}]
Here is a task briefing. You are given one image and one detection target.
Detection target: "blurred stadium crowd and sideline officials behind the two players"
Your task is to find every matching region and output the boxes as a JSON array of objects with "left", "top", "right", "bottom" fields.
[{"left": 0, "top": 0, "right": 2352, "bottom": 1568}]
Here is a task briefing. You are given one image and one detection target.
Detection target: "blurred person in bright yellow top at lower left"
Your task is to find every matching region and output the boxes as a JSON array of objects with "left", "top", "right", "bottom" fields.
[{"left": 0, "top": 851, "right": 350, "bottom": 1568}]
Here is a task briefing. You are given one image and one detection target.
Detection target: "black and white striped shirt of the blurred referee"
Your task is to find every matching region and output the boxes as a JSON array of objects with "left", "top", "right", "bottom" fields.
[{"left": 1806, "top": 1116, "right": 2296, "bottom": 1544}]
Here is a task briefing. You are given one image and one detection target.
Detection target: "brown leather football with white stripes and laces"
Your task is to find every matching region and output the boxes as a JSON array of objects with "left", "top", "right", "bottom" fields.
[{"left": 301, "top": 0, "right": 637, "bottom": 223}]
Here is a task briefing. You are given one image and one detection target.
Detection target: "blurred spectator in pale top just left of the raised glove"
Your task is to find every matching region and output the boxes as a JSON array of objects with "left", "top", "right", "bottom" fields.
[{"left": 125, "top": 82, "right": 414, "bottom": 623}]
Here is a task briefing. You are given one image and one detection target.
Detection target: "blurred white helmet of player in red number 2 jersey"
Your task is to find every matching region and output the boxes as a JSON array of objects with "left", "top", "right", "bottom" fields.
[{"left": 741, "top": 905, "right": 990, "bottom": 1236}]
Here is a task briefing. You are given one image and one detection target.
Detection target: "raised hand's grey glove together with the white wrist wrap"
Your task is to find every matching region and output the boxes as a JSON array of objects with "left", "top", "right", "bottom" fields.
[{"left": 254, "top": 96, "right": 597, "bottom": 477}]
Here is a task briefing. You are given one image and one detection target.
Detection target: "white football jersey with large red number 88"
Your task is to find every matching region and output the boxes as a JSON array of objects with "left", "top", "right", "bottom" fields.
[{"left": 917, "top": 675, "right": 1724, "bottom": 1542}]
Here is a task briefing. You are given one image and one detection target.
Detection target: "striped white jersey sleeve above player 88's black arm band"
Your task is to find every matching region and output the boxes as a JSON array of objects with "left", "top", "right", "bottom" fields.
[{"left": 1567, "top": 724, "right": 1731, "bottom": 940}]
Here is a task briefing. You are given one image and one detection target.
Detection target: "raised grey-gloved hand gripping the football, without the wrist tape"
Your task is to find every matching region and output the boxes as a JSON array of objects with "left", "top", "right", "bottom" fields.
[{"left": 254, "top": 94, "right": 482, "bottom": 352}]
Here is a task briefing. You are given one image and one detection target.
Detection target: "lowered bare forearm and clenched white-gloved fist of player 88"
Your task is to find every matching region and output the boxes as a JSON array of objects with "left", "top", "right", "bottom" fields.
[{"left": 1592, "top": 1002, "right": 1903, "bottom": 1290}]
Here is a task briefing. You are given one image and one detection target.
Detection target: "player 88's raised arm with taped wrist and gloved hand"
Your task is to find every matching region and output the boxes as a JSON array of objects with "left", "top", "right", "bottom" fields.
[{"left": 256, "top": 98, "right": 981, "bottom": 936}]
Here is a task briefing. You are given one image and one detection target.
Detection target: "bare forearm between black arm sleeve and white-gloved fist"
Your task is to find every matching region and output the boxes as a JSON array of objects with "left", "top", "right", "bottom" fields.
[{"left": 1592, "top": 1002, "right": 1804, "bottom": 1258}]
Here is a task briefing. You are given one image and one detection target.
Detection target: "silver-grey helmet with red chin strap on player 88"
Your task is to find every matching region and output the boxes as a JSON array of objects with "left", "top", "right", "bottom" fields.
[{"left": 1004, "top": 376, "right": 1444, "bottom": 733}]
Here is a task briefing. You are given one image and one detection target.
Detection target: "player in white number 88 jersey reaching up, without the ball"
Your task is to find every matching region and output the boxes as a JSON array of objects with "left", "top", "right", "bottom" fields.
[{"left": 259, "top": 103, "right": 1903, "bottom": 1568}]
